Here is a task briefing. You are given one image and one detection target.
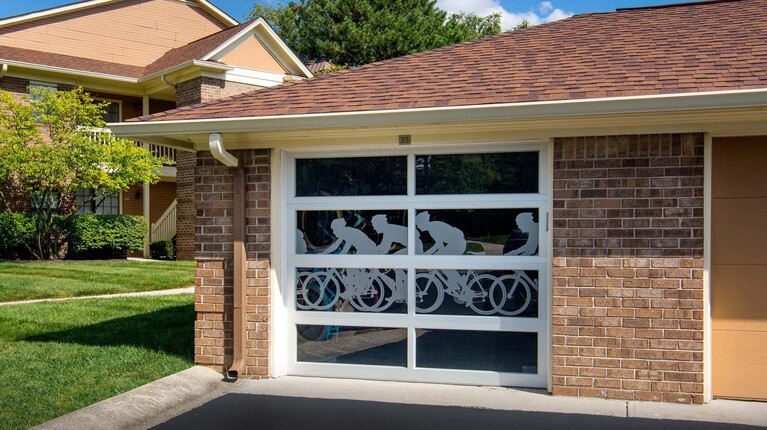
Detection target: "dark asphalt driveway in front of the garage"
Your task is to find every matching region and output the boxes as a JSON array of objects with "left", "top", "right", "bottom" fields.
[{"left": 154, "top": 394, "right": 760, "bottom": 430}]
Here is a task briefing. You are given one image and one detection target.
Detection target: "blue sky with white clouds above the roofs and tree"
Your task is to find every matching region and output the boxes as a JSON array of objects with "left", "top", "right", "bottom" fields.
[{"left": 0, "top": 0, "right": 681, "bottom": 29}]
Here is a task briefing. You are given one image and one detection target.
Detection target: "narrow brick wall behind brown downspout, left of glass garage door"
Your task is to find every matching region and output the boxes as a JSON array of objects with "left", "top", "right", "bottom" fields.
[{"left": 194, "top": 150, "right": 271, "bottom": 377}]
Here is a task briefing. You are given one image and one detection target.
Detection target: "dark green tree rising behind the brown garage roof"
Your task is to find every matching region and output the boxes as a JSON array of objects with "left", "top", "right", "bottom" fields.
[{"left": 249, "top": 0, "right": 501, "bottom": 66}]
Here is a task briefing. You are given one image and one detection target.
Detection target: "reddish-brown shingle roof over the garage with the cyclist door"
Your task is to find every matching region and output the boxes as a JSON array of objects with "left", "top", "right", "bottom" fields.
[{"left": 130, "top": 0, "right": 767, "bottom": 121}]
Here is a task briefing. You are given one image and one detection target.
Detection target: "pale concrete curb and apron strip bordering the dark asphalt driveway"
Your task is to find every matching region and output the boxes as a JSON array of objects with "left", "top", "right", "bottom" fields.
[{"left": 36, "top": 367, "right": 767, "bottom": 430}]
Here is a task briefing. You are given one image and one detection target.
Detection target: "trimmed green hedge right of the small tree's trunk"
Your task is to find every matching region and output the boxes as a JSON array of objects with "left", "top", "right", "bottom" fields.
[{"left": 67, "top": 214, "right": 148, "bottom": 259}]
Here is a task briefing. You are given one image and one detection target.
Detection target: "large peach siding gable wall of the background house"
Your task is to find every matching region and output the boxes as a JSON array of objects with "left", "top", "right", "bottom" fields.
[{"left": 0, "top": 0, "right": 226, "bottom": 66}]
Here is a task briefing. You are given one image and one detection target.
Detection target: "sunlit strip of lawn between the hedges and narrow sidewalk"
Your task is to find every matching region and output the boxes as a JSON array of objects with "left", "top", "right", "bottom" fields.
[{"left": 0, "top": 261, "right": 195, "bottom": 302}]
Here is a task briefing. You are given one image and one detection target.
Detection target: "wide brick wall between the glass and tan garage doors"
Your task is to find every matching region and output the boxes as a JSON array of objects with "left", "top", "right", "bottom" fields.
[{"left": 552, "top": 134, "right": 703, "bottom": 403}]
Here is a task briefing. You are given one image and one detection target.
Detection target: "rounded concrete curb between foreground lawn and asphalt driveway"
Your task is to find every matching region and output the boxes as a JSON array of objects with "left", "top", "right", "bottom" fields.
[{"left": 33, "top": 366, "right": 240, "bottom": 430}]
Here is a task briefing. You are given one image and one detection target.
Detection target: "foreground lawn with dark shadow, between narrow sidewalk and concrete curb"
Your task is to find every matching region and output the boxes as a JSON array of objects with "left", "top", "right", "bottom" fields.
[{"left": 0, "top": 294, "right": 195, "bottom": 429}]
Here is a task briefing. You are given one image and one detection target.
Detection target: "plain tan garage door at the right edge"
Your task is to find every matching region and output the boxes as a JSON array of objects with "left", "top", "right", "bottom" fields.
[{"left": 711, "top": 136, "right": 767, "bottom": 400}]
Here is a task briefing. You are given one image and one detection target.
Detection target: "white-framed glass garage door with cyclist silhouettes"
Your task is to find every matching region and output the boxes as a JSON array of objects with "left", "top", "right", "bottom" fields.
[{"left": 284, "top": 145, "right": 549, "bottom": 387}]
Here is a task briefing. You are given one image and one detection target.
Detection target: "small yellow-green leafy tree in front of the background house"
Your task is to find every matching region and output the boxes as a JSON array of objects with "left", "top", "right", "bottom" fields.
[{"left": 0, "top": 87, "right": 167, "bottom": 259}]
